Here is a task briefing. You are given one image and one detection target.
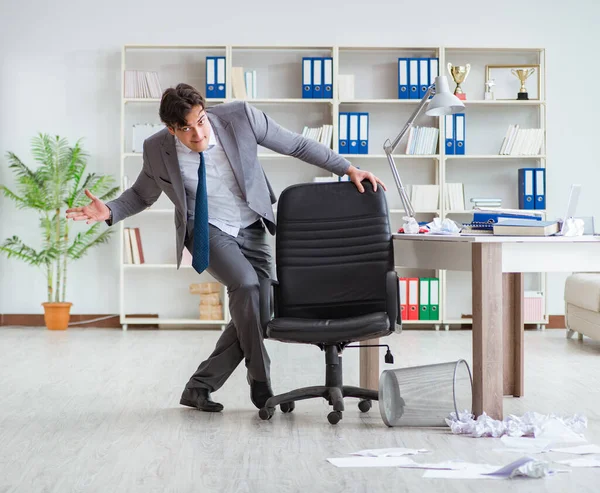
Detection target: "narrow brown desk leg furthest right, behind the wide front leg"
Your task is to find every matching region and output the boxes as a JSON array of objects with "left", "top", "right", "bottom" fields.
[{"left": 502, "top": 273, "right": 524, "bottom": 397}]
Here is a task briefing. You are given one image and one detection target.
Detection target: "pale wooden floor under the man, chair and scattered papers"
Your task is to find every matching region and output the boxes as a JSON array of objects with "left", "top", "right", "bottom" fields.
[{"left": 0, "top": 328, "right": 600, "bottom": 493}]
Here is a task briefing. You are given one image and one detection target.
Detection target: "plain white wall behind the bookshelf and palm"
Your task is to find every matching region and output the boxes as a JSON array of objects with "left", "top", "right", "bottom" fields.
[{"left": 0, "top": 0, "right": 600, "bottom": 314}]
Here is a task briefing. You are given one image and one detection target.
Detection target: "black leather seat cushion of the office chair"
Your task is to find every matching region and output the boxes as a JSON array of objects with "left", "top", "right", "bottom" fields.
[{"left": 267, "top": 312, "right": 390, "bottom": 344}]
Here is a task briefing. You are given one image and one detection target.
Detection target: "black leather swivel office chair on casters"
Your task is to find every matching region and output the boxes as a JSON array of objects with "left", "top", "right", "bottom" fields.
[{"left": 259, "top": 181, "right": 401, "bottom": 424}]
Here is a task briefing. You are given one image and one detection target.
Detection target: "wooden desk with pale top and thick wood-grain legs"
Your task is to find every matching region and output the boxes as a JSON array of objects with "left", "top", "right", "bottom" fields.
[{"left": 360, "top": 234, "right": 600, "bottom": 419}]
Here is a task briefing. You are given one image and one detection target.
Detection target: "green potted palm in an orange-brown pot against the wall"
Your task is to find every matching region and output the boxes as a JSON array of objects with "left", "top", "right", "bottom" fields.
[{"left": 0, "top": 134, "right": 118, "bottom": 330}]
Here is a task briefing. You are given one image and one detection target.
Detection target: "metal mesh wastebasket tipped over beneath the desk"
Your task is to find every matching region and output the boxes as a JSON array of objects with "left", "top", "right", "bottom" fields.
[{"left": 379, "top": 359, "right": 473, "bottom": 427}]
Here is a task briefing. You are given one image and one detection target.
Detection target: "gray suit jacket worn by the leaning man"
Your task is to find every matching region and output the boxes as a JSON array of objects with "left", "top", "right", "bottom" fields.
[{"left": 106, "top": 101, "right": 350, "bottom": 268}]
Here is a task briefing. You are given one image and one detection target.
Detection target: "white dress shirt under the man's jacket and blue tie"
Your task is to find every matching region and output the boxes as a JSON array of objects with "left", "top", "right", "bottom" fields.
[{"left": 175, "top": 122, "right": 260, "bottom": 237}]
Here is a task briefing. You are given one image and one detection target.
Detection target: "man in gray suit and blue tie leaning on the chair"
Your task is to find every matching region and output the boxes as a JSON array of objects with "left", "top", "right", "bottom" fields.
[{"left": 67, "top": 84, "right": 385, "bottom": 412}]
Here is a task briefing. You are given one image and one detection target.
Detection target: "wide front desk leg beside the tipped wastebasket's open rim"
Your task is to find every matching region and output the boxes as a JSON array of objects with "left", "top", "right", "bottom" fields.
[{"left": 472, "top": 243, "right": 503, "bottom": 419}]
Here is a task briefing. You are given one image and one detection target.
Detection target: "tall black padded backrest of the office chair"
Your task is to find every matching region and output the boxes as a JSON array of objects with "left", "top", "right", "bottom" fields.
[{"left": 275, "top": 181, "right": 394, "bottom": 319}]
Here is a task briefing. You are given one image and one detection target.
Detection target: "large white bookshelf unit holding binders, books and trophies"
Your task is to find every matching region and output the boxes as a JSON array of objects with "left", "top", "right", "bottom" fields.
[{"left": 120, "top": 45, "right": 548, "bottom": 329}]
